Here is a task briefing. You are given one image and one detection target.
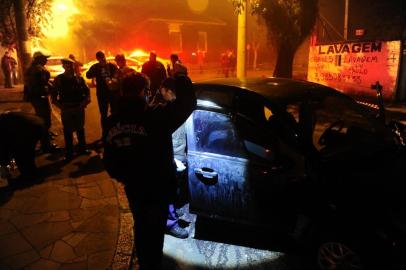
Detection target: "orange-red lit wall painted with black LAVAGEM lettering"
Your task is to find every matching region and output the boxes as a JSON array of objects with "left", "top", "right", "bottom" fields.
[{"left": 307, "top": 41, "right": 400, "bottom": 99}]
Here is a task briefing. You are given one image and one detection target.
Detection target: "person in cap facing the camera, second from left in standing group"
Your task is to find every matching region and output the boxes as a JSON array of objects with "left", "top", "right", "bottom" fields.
[{"left": 52, "top": 58, "right": 90, "bottom": 161}]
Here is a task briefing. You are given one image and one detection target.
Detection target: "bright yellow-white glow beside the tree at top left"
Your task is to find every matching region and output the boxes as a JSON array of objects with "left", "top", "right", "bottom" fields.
[{"left": 44, "top": 0, "right": 79, "bottom": 38}]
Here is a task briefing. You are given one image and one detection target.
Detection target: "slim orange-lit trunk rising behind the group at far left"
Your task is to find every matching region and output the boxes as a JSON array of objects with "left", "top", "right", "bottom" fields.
[{"left": 14, "top": 0, "right": 31, "bottom": 79}]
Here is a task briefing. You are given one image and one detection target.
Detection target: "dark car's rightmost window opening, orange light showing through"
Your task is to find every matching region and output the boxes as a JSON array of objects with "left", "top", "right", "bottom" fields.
[{"left": 313, "top": 96, "right": 376, "bottom": 149}]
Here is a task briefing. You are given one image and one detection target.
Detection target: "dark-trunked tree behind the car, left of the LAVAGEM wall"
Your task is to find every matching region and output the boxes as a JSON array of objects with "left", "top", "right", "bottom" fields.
[{"left": 232, "top": 0, "right": 318, "bottom": 78}]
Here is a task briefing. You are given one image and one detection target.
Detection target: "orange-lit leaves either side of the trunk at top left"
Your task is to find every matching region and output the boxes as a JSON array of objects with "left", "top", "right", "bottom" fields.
[{"left": 0, "top": 0, "right": 52, "bottom": 47}]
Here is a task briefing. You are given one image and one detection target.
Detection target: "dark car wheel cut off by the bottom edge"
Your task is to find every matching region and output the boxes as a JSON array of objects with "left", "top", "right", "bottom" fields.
[{"left": 317, "top": 241, "right": 365, "bottom": 270}]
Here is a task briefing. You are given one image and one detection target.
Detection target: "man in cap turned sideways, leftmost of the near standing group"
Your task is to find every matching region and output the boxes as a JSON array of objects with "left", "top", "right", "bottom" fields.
[{"left": 24, "top": 51, "right": 56, "bottom": 152}]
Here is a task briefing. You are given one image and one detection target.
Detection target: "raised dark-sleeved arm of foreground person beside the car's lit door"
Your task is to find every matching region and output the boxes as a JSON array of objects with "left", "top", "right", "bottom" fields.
[{"left": 163, "top": 76, "right": 196, "bottom": 133}]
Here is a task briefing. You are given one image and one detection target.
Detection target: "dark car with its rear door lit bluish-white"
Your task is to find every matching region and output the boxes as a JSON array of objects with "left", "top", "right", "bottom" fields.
[{"left": 186, "top": 78, "right": 406, "bottom": 270}]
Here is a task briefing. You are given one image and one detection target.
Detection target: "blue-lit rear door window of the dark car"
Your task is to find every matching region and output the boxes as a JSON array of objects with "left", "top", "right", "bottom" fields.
[{"left": 188, "top": 110, "right": 244, "bottom": 157}]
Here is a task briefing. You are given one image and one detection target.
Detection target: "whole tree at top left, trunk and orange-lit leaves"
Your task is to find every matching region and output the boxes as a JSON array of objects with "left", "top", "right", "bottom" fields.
[{"left": 0, "top": 0, "right": 52, "bottom": 73}]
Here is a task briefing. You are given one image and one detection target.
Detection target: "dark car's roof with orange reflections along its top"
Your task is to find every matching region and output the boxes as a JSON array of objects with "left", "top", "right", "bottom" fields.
[{"left": 194, "top": 77, "right": 351, "bottom": 103}]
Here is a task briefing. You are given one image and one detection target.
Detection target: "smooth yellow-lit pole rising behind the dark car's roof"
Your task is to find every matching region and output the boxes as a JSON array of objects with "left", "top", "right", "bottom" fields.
[{"left": 237, "top": 0, "right": 247, "bottom": 80}]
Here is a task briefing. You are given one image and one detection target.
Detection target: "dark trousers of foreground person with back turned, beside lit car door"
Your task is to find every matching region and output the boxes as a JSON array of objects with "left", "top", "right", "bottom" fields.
[{"left": 125, "top": 187, "right": 168, "bottom": 270}]
